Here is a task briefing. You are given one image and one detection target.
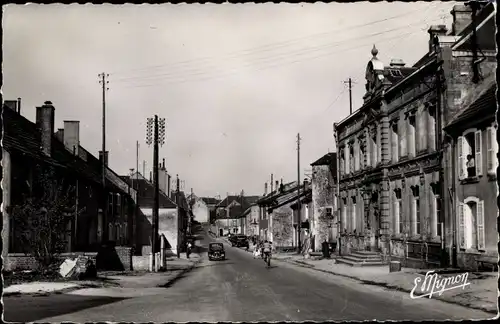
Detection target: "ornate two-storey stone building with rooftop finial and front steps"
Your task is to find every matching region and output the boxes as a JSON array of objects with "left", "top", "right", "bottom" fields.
[{"left": 335, "top": 4, "right": 495, "bottom": 267}]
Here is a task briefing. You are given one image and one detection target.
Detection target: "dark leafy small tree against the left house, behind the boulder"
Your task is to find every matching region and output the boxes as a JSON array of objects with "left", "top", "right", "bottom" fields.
[{"left": 12, "top": 165, "right": 76, "bottom": 271}]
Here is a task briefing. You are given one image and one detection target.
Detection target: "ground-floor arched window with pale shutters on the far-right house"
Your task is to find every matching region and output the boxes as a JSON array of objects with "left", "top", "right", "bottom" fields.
[{"left": 458, "top": 198, "right": 485, "bottom": 250}]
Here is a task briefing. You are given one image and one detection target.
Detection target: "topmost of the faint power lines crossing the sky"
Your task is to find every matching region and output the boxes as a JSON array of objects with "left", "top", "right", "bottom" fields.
[{"left": 108, "top": 5, "right": 434, "bottom": 74}]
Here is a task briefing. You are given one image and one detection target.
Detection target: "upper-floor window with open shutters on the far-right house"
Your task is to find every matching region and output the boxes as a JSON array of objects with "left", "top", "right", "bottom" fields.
[{"left": 457, "top": 131, "right": 483, "bottom": 179}]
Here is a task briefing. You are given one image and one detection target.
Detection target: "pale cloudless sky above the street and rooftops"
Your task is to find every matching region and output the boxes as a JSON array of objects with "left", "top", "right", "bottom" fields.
[{"left": 2, "top": 1, "right": 455, "bottom": 197}]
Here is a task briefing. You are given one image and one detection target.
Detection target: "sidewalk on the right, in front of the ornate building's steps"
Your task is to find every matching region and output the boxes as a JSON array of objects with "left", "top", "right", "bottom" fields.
[{"left": 273, "top": 254, "right": 498, "bottom": 314}]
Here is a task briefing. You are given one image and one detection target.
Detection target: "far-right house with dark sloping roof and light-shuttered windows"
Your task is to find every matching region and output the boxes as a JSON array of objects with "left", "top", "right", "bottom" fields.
[{"left": 445, "top": 75, "right": 498, "bottom": 269}]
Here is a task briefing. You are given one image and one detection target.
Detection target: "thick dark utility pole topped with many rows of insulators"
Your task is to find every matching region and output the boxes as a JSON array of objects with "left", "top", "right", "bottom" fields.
[{"left": 146, "top": 115, "right": 165, "bottom": 272}]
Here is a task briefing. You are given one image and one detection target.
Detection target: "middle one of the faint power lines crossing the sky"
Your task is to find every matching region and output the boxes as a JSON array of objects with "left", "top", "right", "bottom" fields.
[{"left": 108, "top": 19, "right": 434, "bottom": 83}]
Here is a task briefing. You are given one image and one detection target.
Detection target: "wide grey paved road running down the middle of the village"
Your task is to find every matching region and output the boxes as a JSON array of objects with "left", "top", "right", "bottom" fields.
[{"left": 28, "top": 233, "right": 493, "bottom": 322}]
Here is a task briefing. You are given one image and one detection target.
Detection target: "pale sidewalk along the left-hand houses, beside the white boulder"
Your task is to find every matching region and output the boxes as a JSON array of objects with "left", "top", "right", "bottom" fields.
[{"left": 3, "top": 254, "right": 200, "bottom": 297}]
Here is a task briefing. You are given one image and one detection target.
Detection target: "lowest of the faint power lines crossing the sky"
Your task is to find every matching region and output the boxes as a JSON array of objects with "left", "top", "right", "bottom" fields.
[{"left": 117, "top": 32, "right": 422, "bottom": 89}]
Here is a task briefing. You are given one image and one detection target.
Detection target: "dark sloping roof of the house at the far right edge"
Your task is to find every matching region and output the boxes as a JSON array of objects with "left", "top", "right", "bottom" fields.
[{"left": 446, "top": 83, "right": 497, "bottom": 129}]
